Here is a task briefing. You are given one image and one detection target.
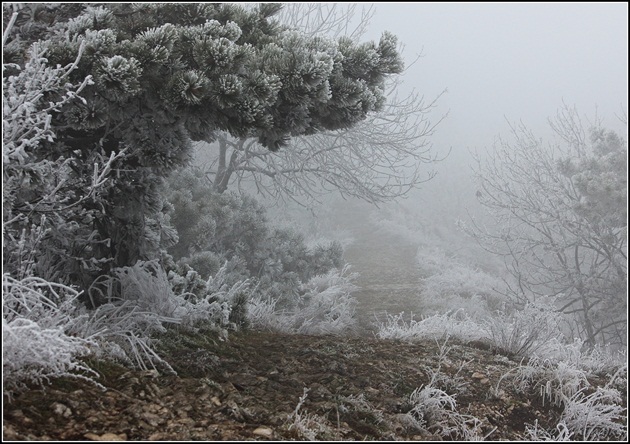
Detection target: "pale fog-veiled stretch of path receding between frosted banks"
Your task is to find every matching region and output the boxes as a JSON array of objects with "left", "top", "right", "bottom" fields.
[{"left": 344, "top": 206, "right": 421, "bottom": 333}]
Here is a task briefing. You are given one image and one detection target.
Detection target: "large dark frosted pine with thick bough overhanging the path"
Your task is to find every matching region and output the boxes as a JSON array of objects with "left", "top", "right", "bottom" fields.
[{"left": 3, "top": 3, "right": 402, "bottom": 283}]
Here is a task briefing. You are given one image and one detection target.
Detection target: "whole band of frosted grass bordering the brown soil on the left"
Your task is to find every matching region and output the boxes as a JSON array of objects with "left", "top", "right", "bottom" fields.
[{"left": 2, "top": 261, "right": 254, "bottom": 388}]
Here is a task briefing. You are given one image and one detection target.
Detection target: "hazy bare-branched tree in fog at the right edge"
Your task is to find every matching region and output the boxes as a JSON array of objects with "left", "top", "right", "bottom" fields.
[{"left": 472, "top": 106, "right": 628, "bottom": 345}]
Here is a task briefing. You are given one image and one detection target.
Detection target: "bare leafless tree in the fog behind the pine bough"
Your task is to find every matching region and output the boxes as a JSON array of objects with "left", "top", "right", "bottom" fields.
[{"left": 198, "top": 3, "right": 445, "bottom": 204}]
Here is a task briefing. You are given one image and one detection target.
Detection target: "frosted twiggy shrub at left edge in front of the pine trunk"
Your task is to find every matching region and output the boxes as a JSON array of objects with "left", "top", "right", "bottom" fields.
[{"left": 2, "top": 26, "right": 124, "bottom": 288}]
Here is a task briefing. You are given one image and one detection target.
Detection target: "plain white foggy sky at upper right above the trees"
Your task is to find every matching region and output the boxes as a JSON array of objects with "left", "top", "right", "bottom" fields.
[{"left": 362, "top": 2, "right": 628, "bottom": 158}]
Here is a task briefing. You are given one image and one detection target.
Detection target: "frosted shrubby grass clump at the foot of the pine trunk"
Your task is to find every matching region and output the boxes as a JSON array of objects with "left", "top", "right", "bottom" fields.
[{"left": 81, "top": 261, "right": 249, "bottom": 371}]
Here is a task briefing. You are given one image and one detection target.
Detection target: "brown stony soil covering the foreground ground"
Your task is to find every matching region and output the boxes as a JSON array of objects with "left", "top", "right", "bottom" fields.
[{"left": 3, "top": 331, "right": 559, "bottom": 441}]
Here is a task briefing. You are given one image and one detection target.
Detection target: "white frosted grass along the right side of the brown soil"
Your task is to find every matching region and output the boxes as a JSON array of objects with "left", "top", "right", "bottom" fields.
[{"left": 377, "top": 304, "right": 627, "bottom": 440}]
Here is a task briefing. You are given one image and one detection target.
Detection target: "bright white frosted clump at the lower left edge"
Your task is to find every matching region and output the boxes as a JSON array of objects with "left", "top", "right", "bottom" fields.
[{"left": 2, "top": 274, "right": 96, "bottom": 390}]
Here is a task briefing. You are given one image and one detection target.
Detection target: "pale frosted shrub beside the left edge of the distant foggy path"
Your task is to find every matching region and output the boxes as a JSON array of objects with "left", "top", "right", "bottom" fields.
[{"left": 249, "top": 267, "right": 357, "bottom": 334}]
